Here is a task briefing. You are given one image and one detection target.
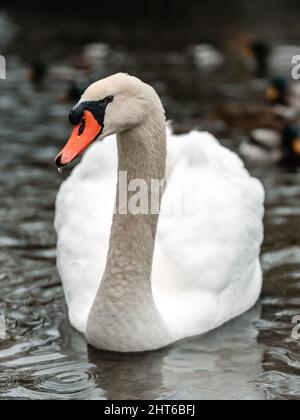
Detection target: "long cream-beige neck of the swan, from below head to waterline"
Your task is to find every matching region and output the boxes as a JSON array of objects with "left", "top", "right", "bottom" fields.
[{"left": 87, "top": 110, "right": 168, "bottom": 351}]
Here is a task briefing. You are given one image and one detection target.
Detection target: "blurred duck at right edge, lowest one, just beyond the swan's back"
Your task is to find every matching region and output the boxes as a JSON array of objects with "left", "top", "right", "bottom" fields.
[{"left": 240, "top": 125, "right": 300, "bottom": 166}]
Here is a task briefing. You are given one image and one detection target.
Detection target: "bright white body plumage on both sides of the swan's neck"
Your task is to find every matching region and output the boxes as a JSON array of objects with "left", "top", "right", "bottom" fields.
[{"left": 55, "top": 130, "right": 264, "bottom": 341}]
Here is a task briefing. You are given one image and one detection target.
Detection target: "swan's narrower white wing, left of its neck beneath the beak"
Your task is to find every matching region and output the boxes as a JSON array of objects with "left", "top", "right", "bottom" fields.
[{"left": 55, "top": 138, "right": 117, "bottom": 332}]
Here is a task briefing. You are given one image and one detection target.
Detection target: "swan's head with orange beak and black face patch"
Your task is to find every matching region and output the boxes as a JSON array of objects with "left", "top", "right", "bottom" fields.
[{"left": 55, "top": 73, "right": 163, "bottom": 168}]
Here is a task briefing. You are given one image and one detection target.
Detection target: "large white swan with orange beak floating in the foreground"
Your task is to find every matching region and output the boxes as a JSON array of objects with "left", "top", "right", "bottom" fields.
[{"left": 55, "top": 74, "right": 264, "bottom": 352}]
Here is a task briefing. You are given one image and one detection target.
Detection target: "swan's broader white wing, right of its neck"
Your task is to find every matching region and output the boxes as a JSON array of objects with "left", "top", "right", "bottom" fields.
[{"left": 153, "top": 132, "right": 264, "bottom": 335}]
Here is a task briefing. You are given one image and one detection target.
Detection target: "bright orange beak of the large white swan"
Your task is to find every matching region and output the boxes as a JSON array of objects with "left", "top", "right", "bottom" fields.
[{"left": 55, "top": 111, "right": 103, "bottom": 168}]
